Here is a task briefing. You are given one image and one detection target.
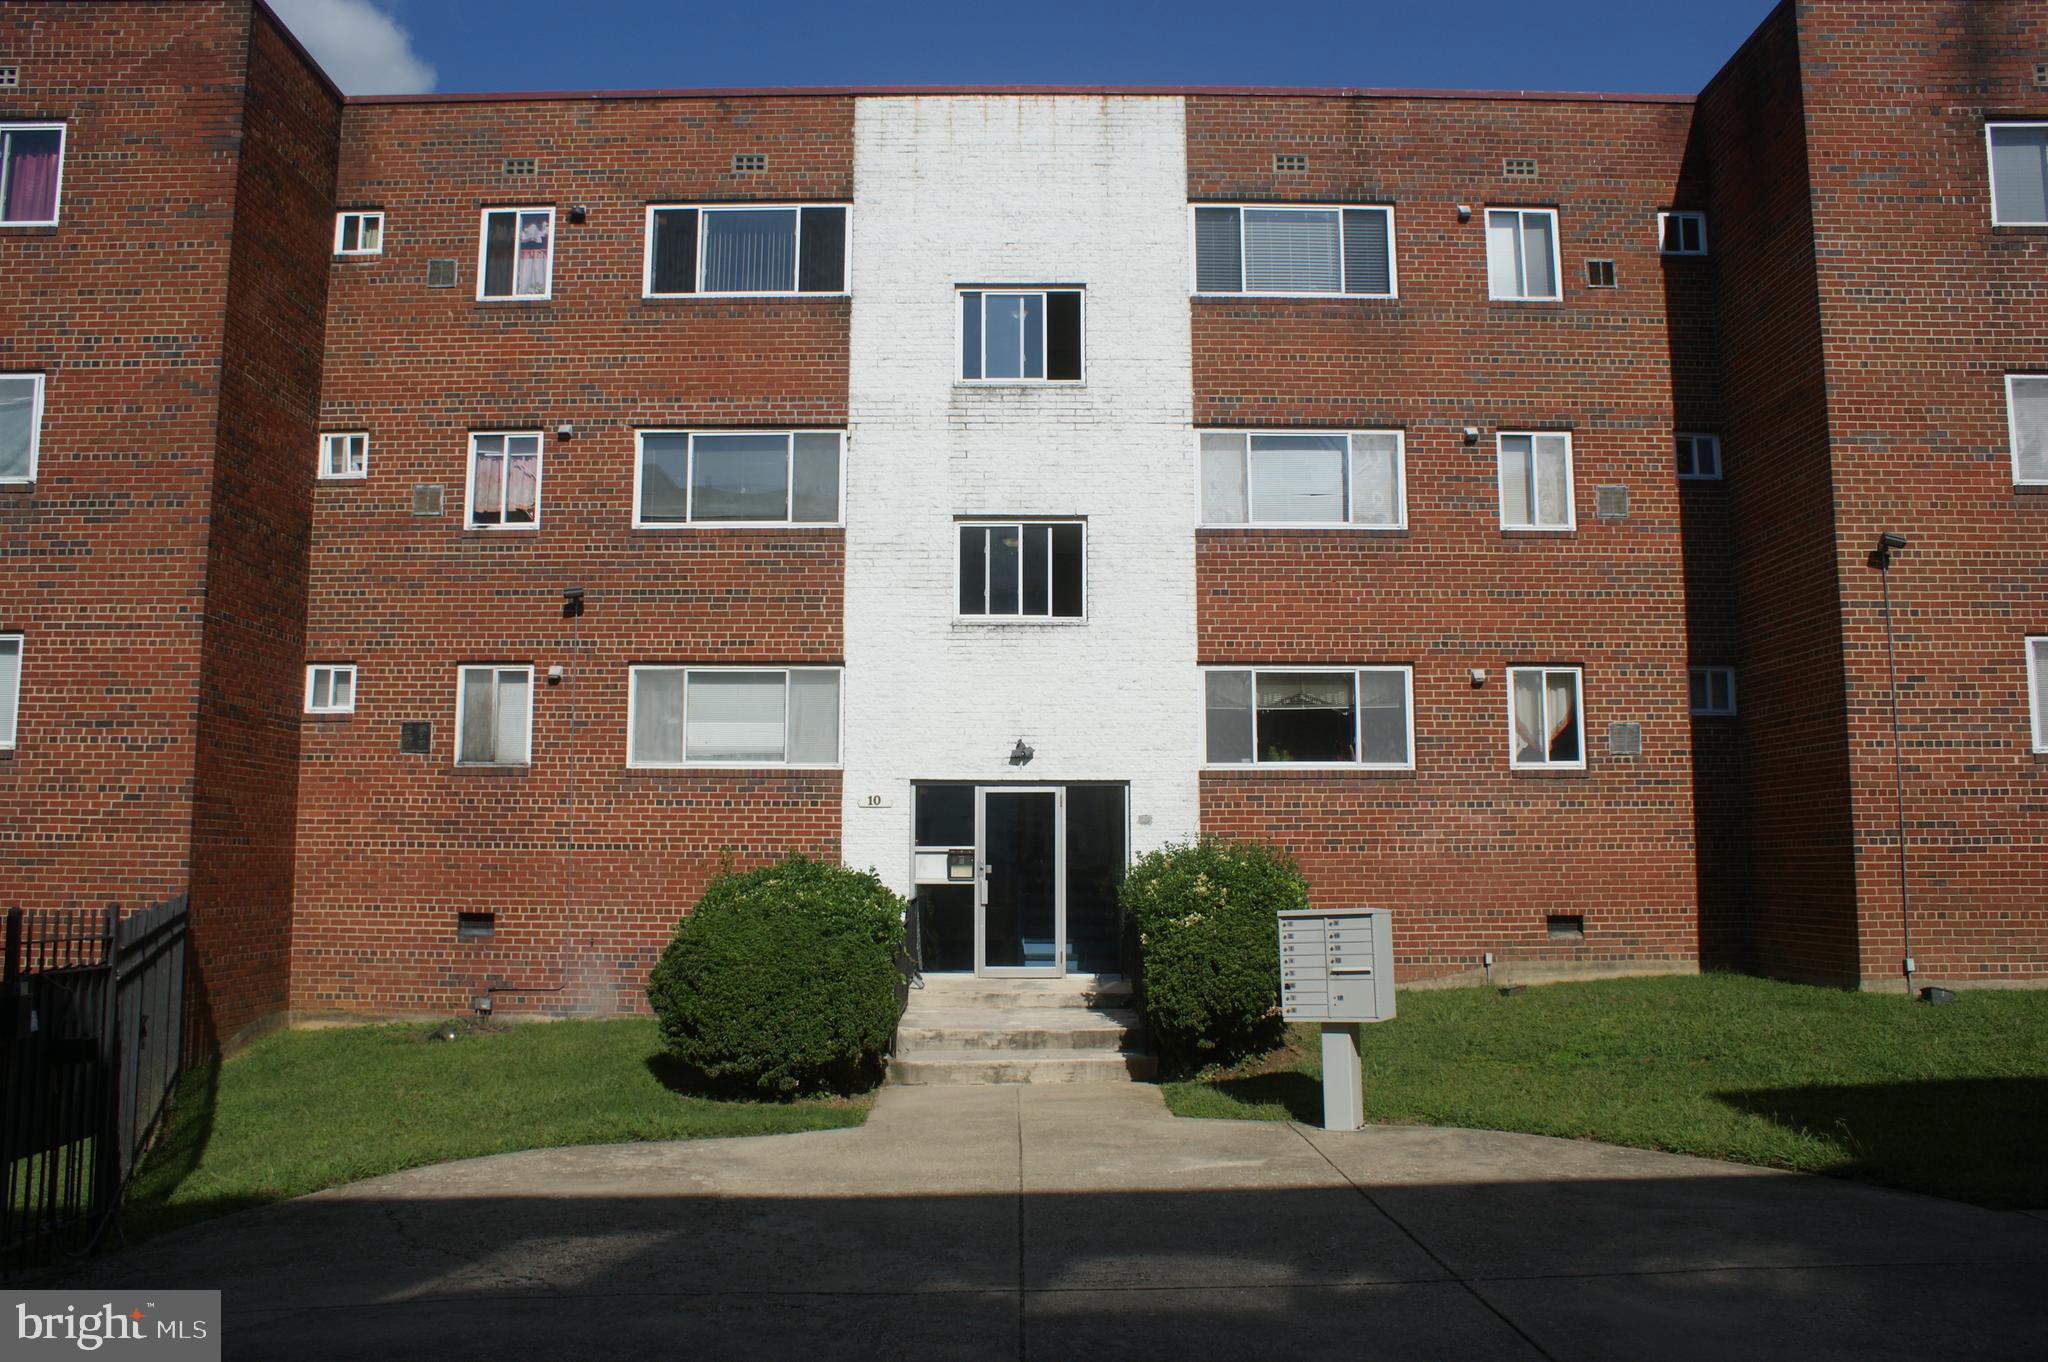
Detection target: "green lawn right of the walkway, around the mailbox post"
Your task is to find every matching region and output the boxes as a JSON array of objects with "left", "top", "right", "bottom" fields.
[{"left": 1165, "top": 975, "right": 2048, "bottom": 1208}]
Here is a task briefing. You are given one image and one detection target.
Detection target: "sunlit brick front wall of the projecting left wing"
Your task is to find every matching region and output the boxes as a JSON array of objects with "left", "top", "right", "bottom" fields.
[{"left": 0, "top": 0, "right": 248, "bottom": 907}]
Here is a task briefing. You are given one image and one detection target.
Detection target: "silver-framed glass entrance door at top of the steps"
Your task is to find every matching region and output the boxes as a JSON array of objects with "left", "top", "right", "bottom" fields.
[{"left": 975, "top": 786, "right": 1067, "bottom": 979}]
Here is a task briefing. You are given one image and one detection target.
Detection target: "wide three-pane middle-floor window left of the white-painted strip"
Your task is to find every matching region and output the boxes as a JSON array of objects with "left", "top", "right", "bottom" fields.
[{"left": 633, "top": 430, "right": 846, "bottom": 528}]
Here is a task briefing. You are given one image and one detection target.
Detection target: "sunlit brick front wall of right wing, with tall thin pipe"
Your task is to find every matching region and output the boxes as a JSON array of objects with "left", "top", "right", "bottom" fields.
[{"left": 1802, "top": 0, "right": 2048, "bottom": 985}]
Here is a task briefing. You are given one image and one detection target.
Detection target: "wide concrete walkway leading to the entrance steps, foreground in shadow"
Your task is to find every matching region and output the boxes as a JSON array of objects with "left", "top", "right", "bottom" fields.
[{"left": 68, "top": 1086, "right": 2048, "bottom": 1362}]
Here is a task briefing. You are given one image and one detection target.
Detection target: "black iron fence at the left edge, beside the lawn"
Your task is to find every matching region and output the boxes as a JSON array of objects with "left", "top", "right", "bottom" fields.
[{"left": 0, "top": 895, "right": 186, "bottom": 1274}]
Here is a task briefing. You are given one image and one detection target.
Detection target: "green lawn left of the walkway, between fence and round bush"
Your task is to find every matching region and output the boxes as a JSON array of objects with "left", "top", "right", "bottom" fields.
[{"left": 123, "top": 1018, "right": 868, "bottom": 1243}]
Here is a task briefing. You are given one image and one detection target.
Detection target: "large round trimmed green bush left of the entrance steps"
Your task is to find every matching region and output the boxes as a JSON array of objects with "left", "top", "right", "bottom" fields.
[{"left": 647, "top": 856, "right": 903, "bottom": 1098}]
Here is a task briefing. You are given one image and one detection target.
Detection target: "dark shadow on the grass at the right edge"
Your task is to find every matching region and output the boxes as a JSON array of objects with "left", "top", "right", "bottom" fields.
[{"left": 1714, "top": 1077, "right": 2048, "bottom": 1210}]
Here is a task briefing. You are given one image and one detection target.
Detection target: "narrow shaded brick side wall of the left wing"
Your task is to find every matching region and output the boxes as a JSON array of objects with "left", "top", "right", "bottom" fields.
[{"left": 193, "top": 12, "right": 342, "bottom": 1038}]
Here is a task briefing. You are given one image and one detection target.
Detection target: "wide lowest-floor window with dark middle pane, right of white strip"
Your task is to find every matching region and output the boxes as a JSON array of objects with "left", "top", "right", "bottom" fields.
[{"left": 1202, "top": 668, "right": 1415, "bottom": 770}]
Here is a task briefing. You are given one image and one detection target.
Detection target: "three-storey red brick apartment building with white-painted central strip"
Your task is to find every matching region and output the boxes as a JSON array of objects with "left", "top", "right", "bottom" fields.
[{"left": 0, "top": 0, "right": 2048, "bottom": 1040}]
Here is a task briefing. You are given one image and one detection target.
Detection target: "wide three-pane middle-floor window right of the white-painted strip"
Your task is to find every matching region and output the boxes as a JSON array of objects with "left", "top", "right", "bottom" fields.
[{"left": 1202, "top": 430, "right": 1407, "bottom": 530}]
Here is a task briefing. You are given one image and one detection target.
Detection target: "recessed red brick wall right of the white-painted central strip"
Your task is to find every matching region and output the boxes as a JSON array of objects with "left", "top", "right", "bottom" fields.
[{"left": 1188, "top": 98, "right": 1712, "bottom": 979}]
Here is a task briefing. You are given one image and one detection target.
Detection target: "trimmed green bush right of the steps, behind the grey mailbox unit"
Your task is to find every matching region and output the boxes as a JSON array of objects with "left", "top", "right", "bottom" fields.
[{"left": 1120, "top": 838, "right": 1309, "bottom": 1073}]
